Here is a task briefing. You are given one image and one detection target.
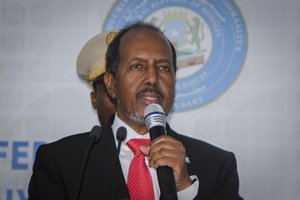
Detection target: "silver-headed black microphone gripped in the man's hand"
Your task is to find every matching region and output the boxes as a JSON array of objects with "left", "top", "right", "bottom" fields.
[{"left": 144, "top": 104, "right": 178, "bottom": 200}]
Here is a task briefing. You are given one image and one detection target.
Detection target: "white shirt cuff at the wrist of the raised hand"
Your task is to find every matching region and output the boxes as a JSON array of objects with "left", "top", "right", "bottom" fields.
[{"left": 177, "top": 175, "right": 199, "bottom": 200}]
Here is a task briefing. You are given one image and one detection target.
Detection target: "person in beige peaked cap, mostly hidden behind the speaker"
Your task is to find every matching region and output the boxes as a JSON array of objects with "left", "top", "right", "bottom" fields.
[{"left": 77, "top": 31, "right": 116, "bottom": 126}]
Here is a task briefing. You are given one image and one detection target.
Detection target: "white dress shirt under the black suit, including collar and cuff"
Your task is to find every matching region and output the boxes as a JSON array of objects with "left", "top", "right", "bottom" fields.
[{"left": 112, "top": 114, "right": 199, "bottom": 200}]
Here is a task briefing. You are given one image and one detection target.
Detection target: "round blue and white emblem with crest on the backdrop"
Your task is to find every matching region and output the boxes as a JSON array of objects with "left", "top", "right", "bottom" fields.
[{"left": 103, "top": 0, "right": 247, "bottom": 111}]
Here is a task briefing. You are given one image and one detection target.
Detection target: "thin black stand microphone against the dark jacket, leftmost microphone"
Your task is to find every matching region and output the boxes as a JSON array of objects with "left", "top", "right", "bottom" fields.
[{"left": 75, "top": 126, "right": 102, "bottom": 200}]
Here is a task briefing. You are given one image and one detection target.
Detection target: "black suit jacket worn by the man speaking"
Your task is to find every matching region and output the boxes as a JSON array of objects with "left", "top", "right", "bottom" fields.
[{"left": 28, "top": 122, "right": 242, "bottom": 200}]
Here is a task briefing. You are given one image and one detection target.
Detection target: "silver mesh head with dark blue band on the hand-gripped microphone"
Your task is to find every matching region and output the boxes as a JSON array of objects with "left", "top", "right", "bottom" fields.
[{"left": 144, "top": 103, "right": 167, "bottom": 130}]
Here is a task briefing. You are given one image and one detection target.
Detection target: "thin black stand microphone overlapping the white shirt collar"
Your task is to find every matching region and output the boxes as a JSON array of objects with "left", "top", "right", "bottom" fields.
[{"left": 112, "top": 126, "right": 127, "bottom": 200}]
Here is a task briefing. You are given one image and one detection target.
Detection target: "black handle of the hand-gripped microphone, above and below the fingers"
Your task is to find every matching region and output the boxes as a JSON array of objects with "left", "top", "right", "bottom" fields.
[{"left": 149, "top": 126, "right": 178, "bottom": 200}]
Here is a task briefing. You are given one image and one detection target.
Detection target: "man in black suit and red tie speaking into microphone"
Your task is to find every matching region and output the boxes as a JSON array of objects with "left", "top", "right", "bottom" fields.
[{"left": 29, "top": 22, "right": 242, "bottom": 200}]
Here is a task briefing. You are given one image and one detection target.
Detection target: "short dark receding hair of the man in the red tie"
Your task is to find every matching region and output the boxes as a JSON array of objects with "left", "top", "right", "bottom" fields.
[{"left": 105, "top": 21, "right": 177, "bottom": 76}]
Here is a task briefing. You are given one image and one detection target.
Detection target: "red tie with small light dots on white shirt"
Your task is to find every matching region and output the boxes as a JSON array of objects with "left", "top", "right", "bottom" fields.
[{"left": 127, "top": 139, "right": 154, "bottom": 200}]
